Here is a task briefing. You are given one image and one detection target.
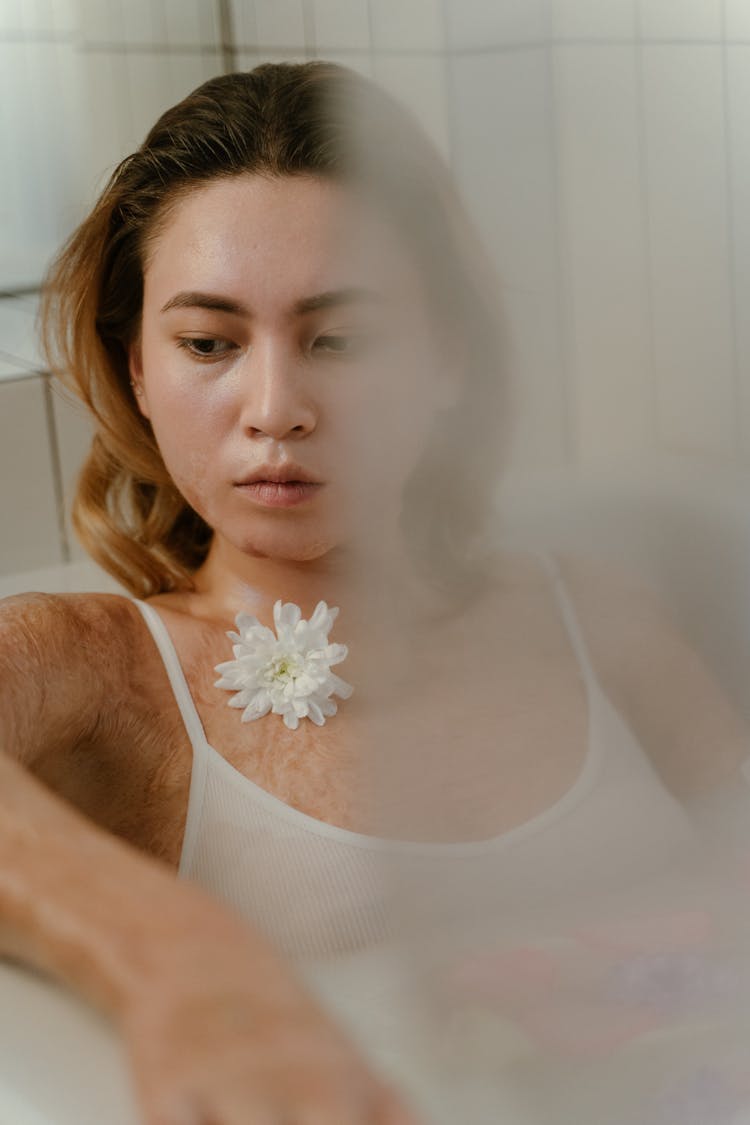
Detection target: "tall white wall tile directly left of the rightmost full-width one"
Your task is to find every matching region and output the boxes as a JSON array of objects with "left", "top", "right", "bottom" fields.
[{"left": 554, "top": 45, "right": 656, "bottom": 460}]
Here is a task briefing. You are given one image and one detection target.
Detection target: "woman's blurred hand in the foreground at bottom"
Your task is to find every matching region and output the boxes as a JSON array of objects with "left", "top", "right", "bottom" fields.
[{"left": 120, "top": 907, "right": 419, "bottom": 1125}]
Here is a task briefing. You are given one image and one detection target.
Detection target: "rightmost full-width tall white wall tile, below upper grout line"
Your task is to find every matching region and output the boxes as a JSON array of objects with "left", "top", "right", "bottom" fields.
[{"left": 643, "top": 45, "right": 737, "bottom": 456}]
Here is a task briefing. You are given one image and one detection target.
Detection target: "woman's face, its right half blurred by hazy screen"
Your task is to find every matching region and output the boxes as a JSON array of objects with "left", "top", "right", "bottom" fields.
[{"left": 130, "top": 174, "right": 454, "bottom": 561}]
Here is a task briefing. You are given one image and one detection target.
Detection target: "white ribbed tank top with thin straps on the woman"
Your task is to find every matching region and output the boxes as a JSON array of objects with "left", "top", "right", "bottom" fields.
[{"left": 129, "top": 557, "right": 694, "bottom": 966}]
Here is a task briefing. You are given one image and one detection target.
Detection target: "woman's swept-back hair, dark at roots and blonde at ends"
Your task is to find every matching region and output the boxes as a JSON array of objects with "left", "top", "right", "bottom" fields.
[{"left": 42, "top": 62, "right": 507, "bottom": 597}]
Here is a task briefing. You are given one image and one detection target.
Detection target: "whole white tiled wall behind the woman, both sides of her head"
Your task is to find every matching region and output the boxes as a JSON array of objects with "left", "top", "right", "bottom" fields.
[{"left": 7, "top": 0, "right": 750, "bottom": 580}]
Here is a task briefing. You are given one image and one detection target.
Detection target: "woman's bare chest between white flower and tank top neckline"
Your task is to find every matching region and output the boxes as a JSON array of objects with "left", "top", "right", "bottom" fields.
[{"left": 167, "top": 634, "right": 588, "bottom": 840}]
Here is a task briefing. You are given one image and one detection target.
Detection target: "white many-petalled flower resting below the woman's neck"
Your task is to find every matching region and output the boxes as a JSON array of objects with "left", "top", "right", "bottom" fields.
[{"left": 214, "top": 601, "right": 354, "bottom": 730}]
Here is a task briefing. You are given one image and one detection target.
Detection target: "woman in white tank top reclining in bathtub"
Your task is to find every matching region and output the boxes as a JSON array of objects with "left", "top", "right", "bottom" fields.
[{"left": 0, "top": 63, "right": 746, "bottom": 1125}]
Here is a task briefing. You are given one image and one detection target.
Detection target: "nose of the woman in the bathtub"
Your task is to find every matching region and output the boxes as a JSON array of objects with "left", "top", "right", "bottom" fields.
[{"left": 242, "top": 344, "right": 317, "bottom": 441}]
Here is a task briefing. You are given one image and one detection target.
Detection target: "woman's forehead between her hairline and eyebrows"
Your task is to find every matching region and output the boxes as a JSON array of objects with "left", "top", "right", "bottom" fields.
[{"left": 140, "top": 174, "right": 421, "bottom": 315}]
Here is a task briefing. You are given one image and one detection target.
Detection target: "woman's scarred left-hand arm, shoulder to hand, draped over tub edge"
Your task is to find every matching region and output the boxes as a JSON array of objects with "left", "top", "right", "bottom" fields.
[{"left": 0, "top": 597, "right": 414, "bottom": 1125}]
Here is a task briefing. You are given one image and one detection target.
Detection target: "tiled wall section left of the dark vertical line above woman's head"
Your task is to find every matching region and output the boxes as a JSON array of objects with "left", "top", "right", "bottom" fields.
[{"left": 0, "top": 0, "right": 231, "bottom": 573}]
